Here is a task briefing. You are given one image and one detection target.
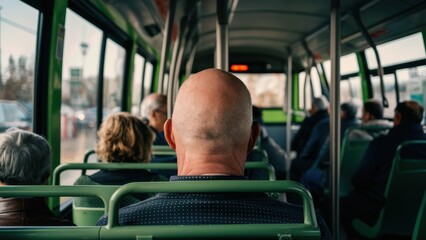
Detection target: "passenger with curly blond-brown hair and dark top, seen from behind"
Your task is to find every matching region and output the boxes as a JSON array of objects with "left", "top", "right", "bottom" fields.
[{"left": 74, "top": 112, "right": 167, "bottom": 207}]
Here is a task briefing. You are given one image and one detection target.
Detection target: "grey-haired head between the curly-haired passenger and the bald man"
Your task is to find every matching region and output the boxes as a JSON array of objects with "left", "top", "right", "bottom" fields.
[{"left": 141, "top": 93, "right": 167, "bottom": 132}]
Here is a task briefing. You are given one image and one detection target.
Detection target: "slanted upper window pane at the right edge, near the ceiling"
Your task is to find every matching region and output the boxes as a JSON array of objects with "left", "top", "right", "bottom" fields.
[{"left": 365, "top": 33, "right": 426, "bottom": 69}]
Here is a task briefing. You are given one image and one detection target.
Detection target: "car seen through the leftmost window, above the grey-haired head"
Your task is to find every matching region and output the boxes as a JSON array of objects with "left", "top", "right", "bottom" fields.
[{"left": 0, "top": 100, "right": 32, "bottom": 132}]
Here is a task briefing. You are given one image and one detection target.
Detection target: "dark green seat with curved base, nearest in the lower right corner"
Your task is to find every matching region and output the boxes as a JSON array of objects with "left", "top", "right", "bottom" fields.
[{"left": 352, "top": 140, "right": 426, "bottom": 238}]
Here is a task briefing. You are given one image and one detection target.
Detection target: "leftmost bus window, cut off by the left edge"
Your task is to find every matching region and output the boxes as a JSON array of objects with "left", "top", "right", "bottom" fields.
[{"left": 0, "top": 1, "right": 39, "bottom": 132}]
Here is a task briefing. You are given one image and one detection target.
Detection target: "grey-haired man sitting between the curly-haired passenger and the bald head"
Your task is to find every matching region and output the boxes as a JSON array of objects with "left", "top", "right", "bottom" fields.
[{"left": 141, "top": 93, "right": 176, "bottom": 178}]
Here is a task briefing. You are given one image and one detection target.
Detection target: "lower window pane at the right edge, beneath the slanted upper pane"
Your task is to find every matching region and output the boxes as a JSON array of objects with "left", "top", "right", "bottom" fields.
[{"left": 396, "top": 66, "right": 426, "bottom": 106}]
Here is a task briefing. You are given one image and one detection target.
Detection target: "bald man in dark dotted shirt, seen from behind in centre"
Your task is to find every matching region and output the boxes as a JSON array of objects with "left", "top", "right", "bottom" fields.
[{"left": 98, "top": 69, "right": 330, "bottom": 239}]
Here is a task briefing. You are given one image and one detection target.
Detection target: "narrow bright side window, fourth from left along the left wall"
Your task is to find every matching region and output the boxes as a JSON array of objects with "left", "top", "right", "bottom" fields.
[{"left": 132, "top": 54, "right": 145, "bottom": 116}]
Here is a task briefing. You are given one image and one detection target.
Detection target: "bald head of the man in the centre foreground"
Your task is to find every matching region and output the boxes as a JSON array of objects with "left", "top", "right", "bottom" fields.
[{"left": 164, "top": 69, "right": 260, "bottom": 175}]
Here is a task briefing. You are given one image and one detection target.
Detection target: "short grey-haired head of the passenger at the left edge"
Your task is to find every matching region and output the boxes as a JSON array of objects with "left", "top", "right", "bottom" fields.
[{"left": 0, "top": 129, "right": 51, "bottom": 185}]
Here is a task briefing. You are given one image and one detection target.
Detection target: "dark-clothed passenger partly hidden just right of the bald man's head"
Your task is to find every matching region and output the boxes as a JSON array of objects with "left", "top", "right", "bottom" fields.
[{"left": 247, "top": 106, "right": 287, "bottom": 180}]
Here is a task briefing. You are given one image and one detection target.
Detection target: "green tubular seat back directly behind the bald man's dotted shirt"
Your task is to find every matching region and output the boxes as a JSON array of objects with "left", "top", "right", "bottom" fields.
[{"left": 100, "top": 180, "right": 321, "bottom": 239}]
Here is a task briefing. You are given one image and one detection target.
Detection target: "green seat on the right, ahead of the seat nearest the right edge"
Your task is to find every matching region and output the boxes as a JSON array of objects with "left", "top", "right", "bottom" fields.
[{"left": 340, "top": 126, "right": 389, "bottom": 196}]
